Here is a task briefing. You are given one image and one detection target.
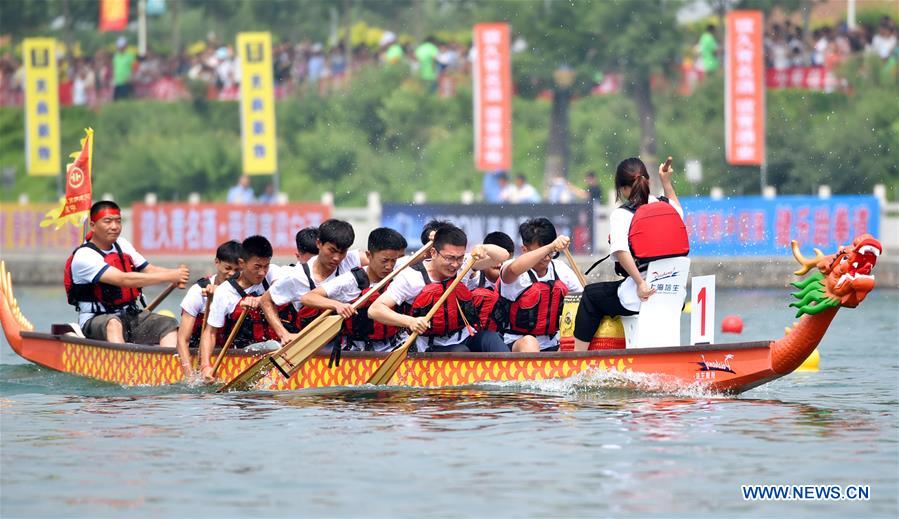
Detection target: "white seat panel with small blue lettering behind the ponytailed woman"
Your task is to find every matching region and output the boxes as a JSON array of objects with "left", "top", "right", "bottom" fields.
[{"left": 621, "top": 257, "right": 690, "bottom": 349}]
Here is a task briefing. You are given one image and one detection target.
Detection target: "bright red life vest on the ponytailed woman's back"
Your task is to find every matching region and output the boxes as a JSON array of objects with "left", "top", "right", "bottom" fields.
[{"left": 615, "top": 196, "right": 690, "bottom": 277}]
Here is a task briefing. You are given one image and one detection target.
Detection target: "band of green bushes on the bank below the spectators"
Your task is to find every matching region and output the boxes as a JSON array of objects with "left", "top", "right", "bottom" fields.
[{"left": 0, "top": 69, "right": 899, "bottom": 205}]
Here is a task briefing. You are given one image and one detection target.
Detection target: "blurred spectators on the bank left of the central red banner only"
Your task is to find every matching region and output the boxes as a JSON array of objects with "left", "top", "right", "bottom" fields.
[{"left": 0, "top": 31, "right": 470, "bottom": 105}]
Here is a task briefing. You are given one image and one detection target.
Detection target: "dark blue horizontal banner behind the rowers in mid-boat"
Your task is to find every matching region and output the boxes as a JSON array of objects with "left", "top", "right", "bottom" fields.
[{"left": 381, "top": 203, "right": 593, "bottom": 254}]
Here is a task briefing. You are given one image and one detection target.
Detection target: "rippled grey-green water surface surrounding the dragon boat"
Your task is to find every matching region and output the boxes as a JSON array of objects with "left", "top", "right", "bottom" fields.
[{"left": 0, "top": 288, "right": 899, "bottom": 517}]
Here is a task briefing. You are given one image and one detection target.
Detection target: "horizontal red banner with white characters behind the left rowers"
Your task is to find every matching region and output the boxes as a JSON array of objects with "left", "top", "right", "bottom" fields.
[{"left": 130, "top": 204, "right": 331, "bottom": 256}]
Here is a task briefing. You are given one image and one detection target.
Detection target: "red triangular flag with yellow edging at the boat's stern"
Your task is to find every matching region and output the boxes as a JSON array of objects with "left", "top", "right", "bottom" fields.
[{"left": 41, "top": 128, "right": 94, "bottom": 229}]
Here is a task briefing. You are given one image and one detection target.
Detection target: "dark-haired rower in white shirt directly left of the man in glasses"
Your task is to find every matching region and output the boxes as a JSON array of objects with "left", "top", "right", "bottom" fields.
[{"left": 301, "top": 227, "right": 407, "bottom": 351}]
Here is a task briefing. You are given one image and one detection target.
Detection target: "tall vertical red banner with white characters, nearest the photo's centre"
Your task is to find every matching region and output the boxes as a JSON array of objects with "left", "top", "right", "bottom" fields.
[{"left": 474, "top": 23, "right": 512, "bottom": 171}]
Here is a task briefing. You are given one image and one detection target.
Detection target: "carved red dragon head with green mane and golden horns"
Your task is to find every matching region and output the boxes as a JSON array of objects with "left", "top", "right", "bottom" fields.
[{"left": 790, "top": 234, "right": 883, "bottom": 317}]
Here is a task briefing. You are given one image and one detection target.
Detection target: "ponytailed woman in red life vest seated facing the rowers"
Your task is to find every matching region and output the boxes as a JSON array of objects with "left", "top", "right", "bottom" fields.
[{"left": 574, "top": 157, "right": 689, "bottom": 351}]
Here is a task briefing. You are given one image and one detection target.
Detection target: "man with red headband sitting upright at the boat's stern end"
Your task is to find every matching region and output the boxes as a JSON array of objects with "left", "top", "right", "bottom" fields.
[{"left": 64, "top": 200, "right": 190, "bottom": 348}]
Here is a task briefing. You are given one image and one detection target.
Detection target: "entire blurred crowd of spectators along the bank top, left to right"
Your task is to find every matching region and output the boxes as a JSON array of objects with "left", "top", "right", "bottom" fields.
[{"left": 0, "top": 16, "right": 899, "bottom": 106}]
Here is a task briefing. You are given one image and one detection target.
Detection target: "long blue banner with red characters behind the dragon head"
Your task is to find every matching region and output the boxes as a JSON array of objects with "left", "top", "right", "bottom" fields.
[{"left": 680, "top": 195, "right": 880, "bottom": 256}]
